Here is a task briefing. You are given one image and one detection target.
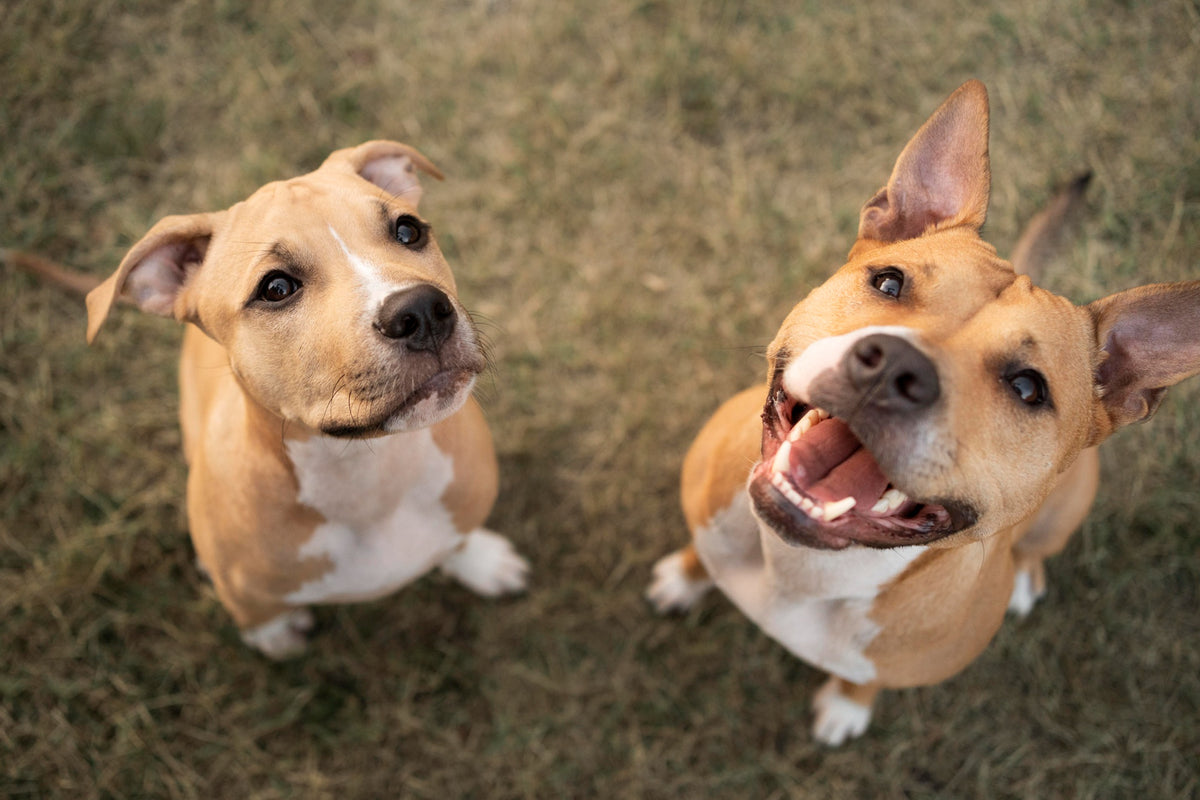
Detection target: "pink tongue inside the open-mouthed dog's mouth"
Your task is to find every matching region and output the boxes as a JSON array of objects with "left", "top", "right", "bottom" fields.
[{"left": 791, "top": 419, "right": 888, "bottom": 511}]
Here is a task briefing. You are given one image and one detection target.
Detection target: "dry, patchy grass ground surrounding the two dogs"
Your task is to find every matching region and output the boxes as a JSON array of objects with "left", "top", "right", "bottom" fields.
[{"left": 0, "top": 0, "right": 1200, "bottom": 799}]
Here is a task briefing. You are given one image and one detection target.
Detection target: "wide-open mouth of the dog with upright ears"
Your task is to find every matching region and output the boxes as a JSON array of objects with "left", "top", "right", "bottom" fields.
[{"left": 750, "top": 371, "right": 976, "bottom": 549}]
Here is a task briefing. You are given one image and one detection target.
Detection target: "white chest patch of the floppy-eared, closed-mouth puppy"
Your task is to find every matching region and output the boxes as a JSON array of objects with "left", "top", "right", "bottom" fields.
[{"left": 287, "top": 429, "right": 462, "bottom": 603}]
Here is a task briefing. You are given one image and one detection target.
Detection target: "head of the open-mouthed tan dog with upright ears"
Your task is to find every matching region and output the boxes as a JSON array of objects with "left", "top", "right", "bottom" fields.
[{"left": 750, "top": 82, "right": 1200, "bottom": 548}]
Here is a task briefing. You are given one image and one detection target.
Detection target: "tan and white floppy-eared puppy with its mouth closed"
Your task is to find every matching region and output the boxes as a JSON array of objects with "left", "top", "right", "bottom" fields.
[{"left": 88, "top": 142, "right": 528, "bottom": 657}]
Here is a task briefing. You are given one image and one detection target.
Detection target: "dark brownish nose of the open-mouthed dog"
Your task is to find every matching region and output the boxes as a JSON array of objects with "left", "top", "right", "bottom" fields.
[{"left": 846, "top": 333, "right": 941, "bottom": 411}]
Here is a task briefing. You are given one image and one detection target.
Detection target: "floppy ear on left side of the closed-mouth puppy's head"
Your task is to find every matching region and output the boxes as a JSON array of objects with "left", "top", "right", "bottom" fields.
[{"left": 88, "top": 213, "right": 217, "bottom": 344}]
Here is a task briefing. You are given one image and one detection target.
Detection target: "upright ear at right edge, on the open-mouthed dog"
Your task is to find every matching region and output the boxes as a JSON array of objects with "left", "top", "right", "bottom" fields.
[{"left": 1087, "top": 281, "right": 1200, "bottom": 440}]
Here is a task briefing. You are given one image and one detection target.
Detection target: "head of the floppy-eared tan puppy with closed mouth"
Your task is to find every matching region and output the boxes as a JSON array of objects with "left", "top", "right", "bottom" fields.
[{"left": 88, "top": 142, "right": 485, "bottom": 437}]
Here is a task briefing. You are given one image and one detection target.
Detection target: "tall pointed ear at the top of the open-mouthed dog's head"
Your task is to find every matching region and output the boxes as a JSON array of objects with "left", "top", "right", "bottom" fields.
[{"left": 858, "top": 80, "right": 991, "bottom": 242}]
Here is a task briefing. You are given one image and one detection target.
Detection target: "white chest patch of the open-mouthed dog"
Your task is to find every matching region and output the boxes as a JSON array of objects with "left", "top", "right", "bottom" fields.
[{"left": 696, "top": 492, "right": 925, "bottom": 684}]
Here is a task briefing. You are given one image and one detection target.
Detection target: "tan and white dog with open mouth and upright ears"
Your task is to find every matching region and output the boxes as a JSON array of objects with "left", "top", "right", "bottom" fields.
[{"left": 648, "top": 82, "right": 1200, "bottom": 745}]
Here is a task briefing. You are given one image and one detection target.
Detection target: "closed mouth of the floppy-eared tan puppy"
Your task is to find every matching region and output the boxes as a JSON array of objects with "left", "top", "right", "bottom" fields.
[{"left": 320, "top": 368, "right": 479, "bottom": 439}]
